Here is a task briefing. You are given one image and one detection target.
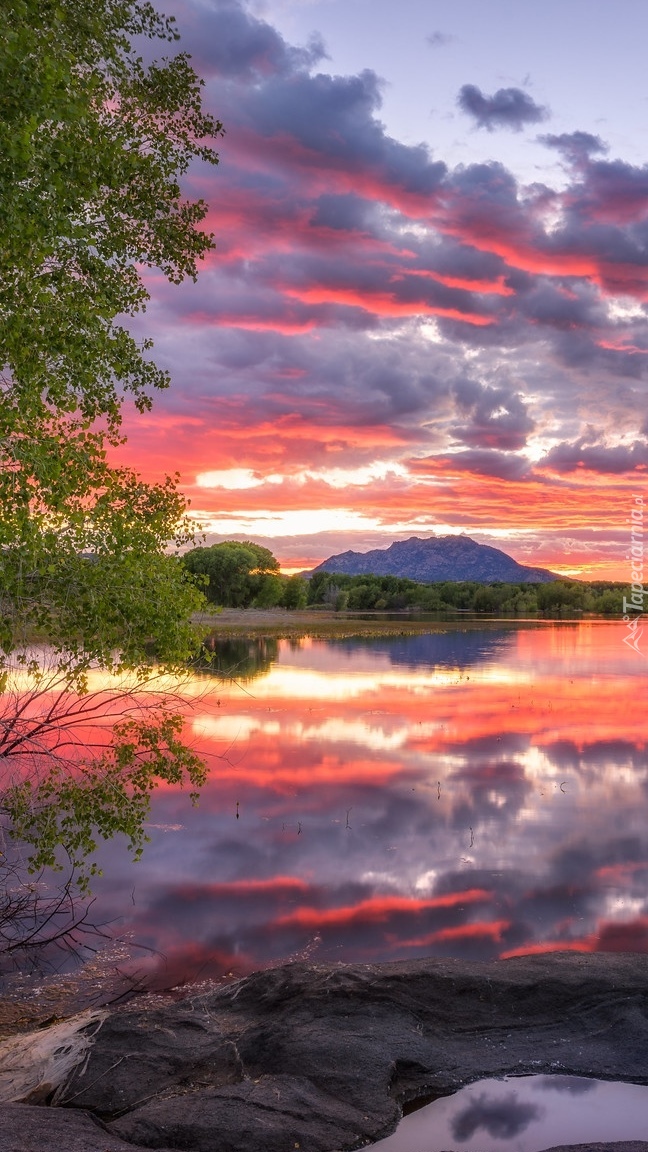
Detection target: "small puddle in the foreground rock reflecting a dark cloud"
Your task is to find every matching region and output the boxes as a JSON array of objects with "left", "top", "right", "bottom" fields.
[{"left": 372, "top": 1076, "right": 648, "bottom": 1152}]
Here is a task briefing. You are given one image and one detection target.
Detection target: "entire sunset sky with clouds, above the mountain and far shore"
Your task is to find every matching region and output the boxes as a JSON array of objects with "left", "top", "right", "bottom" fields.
[{"left": 118, "top": 0, "right": 648, "bottom": 582}]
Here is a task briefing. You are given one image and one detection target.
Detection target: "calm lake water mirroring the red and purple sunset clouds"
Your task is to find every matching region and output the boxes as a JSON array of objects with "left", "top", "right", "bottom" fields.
[{"left": 89, "top": 622, "right": 648, "bottom": 983}]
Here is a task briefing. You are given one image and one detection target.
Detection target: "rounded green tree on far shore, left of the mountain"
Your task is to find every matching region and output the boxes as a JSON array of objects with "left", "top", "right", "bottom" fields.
[{"left": 182, "top": 540, "right": 284, "bottom": 608}]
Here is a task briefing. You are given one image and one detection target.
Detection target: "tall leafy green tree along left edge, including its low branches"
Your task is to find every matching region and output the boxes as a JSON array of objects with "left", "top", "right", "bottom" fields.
[{"left": 0, "top": 0, "right": 221, "bottom": 967}]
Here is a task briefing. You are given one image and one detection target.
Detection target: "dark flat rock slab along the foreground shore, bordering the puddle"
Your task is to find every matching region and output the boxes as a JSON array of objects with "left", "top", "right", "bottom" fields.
[{"left": 6, "top": 953, "right": 648, "bottom": 1152}]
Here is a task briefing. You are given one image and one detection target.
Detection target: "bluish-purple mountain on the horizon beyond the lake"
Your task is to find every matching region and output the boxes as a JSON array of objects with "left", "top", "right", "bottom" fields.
[{"left": 310, "top": 536, "right": 560, "bottom": 584}]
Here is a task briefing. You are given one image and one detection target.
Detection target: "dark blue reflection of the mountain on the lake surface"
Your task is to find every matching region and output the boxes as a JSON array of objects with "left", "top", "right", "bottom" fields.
[{"left": 331, "top": 628, "right": 517, "bottom": 668}]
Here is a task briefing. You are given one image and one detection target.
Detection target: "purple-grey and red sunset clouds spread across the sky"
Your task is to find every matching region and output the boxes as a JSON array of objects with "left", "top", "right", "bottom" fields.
[{"left": 106, "top": 0, "right": 648, "bottom": 568}]
